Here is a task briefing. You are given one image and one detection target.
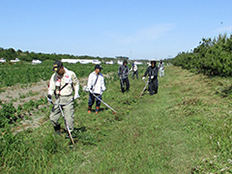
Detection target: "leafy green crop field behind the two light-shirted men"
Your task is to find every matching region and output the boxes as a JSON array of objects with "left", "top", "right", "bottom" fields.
[{"left": 0, "top": 61, "right": 118, "bottom": 88}]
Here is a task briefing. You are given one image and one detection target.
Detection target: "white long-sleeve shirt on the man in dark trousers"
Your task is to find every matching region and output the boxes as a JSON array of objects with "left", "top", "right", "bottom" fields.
[{"left": 87, "top": 71, "right": 106, "bottom": 95}]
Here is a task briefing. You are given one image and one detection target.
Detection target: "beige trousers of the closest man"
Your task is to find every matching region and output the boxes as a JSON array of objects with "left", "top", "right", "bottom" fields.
[{"left": 50, "top": 95, "right": 74, "bottom": 130}]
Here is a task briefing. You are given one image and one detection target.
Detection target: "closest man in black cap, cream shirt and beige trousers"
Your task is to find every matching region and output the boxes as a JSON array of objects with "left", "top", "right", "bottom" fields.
[{"left": 47, "top": 61, "right": 80, "bottom": 134}]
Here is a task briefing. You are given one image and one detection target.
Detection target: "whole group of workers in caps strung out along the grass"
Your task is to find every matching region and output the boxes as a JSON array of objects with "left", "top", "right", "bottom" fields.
[{"left": 47, "top": 60, "right": 164, "bottom": 134}]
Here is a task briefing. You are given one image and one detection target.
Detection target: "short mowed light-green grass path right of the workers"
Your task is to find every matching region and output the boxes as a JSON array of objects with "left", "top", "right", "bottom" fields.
[{"left": 71, "top": 66, "right": 231, "bottom": 173}]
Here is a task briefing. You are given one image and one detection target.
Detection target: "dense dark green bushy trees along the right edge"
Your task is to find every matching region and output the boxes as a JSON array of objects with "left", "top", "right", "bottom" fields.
[{"left": 172, "top": 34, "right": 232, "bottom": 77}]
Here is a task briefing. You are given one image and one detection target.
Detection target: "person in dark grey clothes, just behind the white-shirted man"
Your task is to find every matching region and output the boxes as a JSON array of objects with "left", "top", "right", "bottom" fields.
[{"left": 118, "top": 60, "right": 130, "bottom": 93}]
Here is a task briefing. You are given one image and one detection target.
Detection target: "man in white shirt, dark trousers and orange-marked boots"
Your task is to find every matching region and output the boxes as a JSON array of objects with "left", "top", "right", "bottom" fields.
[{"left": 87, "top": 65, "right": 106, "bottom": 114}]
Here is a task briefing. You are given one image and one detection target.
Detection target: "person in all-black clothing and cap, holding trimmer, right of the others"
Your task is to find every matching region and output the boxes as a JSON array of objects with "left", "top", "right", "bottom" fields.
[{"left": 142, "top": 61, "right": 159, "bottom": 95}]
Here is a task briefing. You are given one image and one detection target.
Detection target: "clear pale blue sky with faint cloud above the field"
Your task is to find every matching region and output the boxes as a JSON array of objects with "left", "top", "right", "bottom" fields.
[{"left": 0, "top": 0, "right": 232, "bottom": 60}]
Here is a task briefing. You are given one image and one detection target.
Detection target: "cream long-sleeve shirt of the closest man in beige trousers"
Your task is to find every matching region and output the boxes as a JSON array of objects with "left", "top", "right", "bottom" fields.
[{"left": 48, "top": 68, "right": 79, "bottom": 96}]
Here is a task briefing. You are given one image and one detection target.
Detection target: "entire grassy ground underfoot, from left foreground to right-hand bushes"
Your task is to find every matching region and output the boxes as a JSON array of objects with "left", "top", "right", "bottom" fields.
[{"left": 0, "top": 66, "right": 232, "bottom": 174}]
